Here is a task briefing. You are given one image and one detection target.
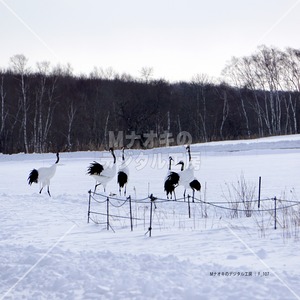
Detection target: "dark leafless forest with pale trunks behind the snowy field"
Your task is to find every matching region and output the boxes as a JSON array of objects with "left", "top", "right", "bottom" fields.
[{"left": 0, "top": 46, "right": 300, "bottom": 153}]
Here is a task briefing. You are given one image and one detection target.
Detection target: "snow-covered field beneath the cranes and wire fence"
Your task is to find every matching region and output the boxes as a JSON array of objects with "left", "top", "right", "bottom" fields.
[{"left": 0, "top": 135, "right": 300, "bottom": 300}]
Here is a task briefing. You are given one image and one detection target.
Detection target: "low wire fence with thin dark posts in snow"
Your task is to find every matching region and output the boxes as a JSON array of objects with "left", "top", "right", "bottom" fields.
[{"left": 87, "top": 191, "right": 300, "bottom": 236}]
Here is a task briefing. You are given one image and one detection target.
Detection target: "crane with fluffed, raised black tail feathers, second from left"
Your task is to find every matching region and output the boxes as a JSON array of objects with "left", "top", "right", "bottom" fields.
[{"left": 87, "top": 148, "right": 116, "bottom": 193}]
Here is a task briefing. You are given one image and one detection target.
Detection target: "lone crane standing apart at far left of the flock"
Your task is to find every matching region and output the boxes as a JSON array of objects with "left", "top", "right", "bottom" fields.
[{"left": 27, "top": 153, "right": 59, "bottom": 197}]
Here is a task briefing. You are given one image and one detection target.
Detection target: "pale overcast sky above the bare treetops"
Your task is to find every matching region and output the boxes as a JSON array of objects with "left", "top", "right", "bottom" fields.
[{"left": 0, "top": 0, "right": 300, "bottom": 82}]
